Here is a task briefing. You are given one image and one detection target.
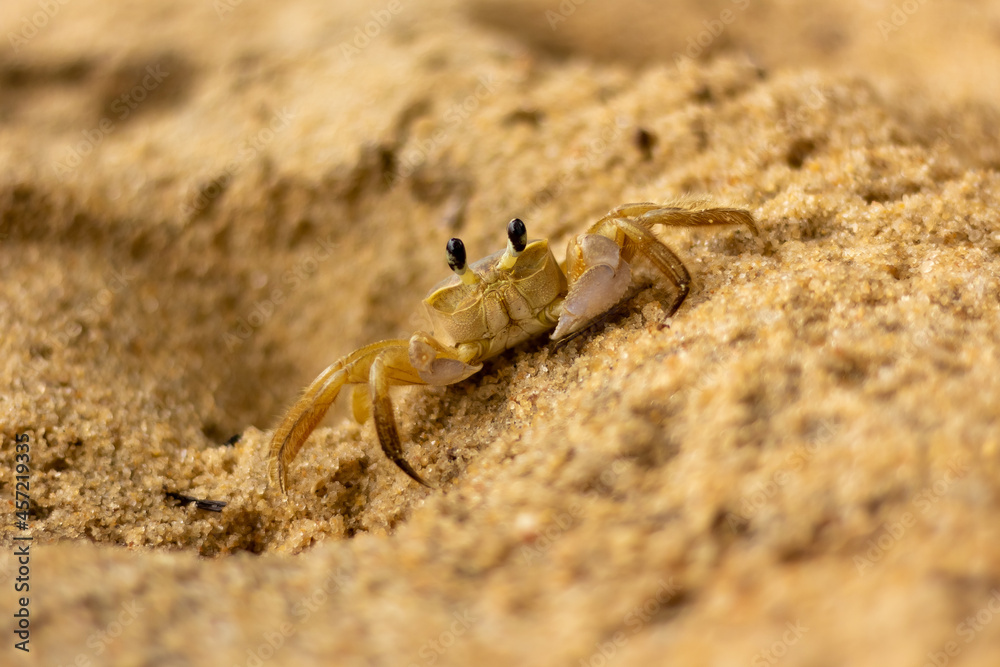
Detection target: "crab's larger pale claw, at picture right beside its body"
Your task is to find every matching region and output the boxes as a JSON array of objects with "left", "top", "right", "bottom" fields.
[{"left": 552, "top": 234, "right": 632, "bottom": 340}]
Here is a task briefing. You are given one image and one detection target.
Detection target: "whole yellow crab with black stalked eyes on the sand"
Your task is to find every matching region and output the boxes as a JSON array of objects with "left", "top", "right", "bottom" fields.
[{"left": 268, "top": 203, "right": 758, "bottom": 494}]
